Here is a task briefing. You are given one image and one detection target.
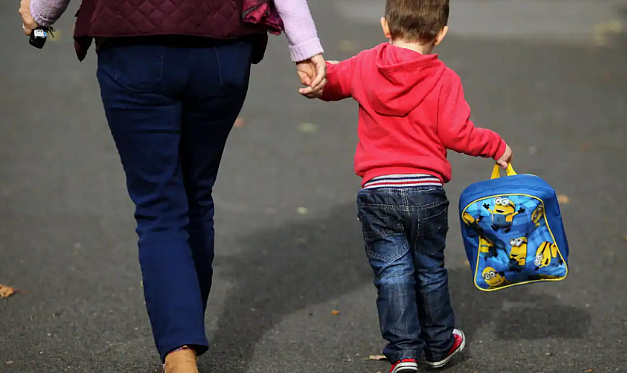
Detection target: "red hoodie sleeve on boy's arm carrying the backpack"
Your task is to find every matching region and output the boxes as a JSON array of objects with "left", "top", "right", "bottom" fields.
[{"left": 438, "top": 71, "right": 507, "bottom": 160}]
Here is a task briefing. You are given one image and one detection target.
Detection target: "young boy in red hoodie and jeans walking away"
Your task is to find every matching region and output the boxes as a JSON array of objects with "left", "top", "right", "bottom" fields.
[{"left": 314, "top": 0, "right": 512, "bottom": 373}]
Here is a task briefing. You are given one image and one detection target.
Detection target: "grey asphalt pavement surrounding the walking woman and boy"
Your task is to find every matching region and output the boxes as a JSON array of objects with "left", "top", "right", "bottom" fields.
[{"left": 0, "top": 0, "right": 627, "bottom": 373}]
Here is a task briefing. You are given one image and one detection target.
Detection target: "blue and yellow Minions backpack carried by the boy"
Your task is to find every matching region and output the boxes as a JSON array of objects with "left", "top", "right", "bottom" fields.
[{"left": 459, "top": 164, "right": 568, "bottom": 291}]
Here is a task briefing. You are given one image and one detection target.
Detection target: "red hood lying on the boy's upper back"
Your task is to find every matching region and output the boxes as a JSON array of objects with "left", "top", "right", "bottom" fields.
[{"left": 366, "top": 44, "right": 446, "bottom": 117}]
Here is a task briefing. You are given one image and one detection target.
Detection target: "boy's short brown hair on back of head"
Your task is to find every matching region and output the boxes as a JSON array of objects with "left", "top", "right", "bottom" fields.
[{"left": 385, "top": 0, "right": 449, "bottom": 43}]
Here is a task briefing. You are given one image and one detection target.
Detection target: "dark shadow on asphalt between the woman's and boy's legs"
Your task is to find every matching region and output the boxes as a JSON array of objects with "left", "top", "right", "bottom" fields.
[{"left": 207, "top": 204, "right": 372, "bottom": 373}]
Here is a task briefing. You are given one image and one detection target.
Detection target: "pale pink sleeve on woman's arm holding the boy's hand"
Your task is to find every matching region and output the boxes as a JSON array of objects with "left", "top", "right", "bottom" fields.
[{"left": 274, "top": 0, "right": 324, "bottom": 62}]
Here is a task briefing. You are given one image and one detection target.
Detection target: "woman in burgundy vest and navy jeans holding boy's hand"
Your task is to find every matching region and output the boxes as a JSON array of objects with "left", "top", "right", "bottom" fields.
[{"left": 20, "top": 0, "right": 326, "bottom": 373}]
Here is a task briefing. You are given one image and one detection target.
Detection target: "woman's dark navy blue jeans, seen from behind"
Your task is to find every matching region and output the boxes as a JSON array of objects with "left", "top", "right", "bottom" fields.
[{"left": 98, "top": 37, "right": 252, "bottom": 360}]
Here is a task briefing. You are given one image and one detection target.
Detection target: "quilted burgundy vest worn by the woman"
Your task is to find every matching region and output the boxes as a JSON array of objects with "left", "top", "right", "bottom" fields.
[{"left": 74, "top": 0, "right": 267, "bottom": 62}]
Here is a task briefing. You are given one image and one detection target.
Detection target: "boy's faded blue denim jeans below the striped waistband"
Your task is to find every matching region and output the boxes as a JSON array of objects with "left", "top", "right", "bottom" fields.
[{"left": 357, "top": 187, "right": 455, "bottom": 362}]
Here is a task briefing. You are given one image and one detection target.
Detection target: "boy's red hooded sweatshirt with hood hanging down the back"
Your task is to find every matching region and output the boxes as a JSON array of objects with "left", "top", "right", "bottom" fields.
[{"left": 321, "top": 43, "right": 505, "bottom": 185}]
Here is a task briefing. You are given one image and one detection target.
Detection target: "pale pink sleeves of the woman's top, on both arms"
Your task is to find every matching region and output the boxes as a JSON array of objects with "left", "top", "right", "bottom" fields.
[{"left": 30, "top": 0, "right": 323, "bottom": 62}]
